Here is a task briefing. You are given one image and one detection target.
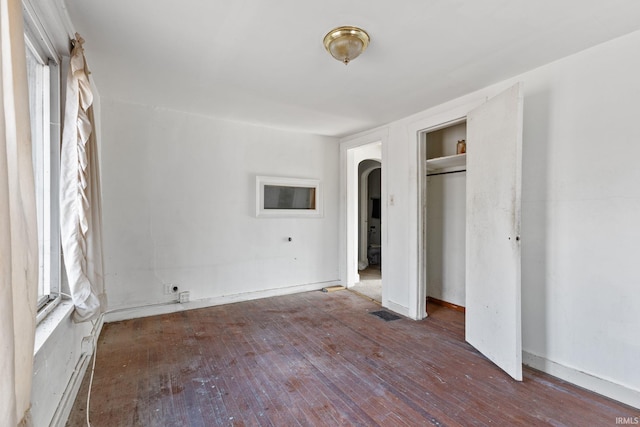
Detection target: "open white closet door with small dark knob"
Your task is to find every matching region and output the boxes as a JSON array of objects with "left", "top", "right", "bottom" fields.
[{"left": 465, "top": 83, "right": 523, "bottom": 381}]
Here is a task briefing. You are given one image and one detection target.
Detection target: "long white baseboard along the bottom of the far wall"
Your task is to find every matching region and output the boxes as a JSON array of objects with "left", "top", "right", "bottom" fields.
[{"left": 105, "top": 280, "right": 339, "bottom": 322}]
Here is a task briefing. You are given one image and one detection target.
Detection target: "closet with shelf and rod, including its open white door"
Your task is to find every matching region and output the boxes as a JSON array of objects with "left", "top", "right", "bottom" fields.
[{"left": 416, "top": 83, "right": 524, "bottom": 380}]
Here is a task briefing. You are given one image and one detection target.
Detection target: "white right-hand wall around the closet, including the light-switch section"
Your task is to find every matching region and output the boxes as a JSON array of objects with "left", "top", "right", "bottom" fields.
[{"left": 343, "top": 32, "right": 640, "bottom": 406}]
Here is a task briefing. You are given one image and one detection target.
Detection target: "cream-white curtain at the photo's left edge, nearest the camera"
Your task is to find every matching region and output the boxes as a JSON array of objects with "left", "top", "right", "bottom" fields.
[{"left": 0, "top": 0, "right": 38, "bottom": 426}]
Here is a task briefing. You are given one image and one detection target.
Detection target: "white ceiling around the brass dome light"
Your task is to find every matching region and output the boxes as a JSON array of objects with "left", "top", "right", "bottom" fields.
[{"left": 65, "top": 0, "right": 640, "bottom": 135}]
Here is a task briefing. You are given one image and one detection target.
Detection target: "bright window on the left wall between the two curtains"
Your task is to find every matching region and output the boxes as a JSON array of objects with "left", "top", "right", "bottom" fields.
[{"left": 25, "top": 27, "right": 60, "bottom": 320}]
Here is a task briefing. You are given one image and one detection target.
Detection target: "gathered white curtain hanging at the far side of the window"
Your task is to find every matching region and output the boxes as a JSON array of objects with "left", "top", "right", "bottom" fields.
[{"left": 60, "top": 34, "right": 106, "bottom": 322}]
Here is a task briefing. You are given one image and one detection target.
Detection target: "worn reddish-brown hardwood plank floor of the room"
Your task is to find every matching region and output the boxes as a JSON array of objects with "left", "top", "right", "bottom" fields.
[{"left": 67, "top": 291, "right": 640, "bottom": 427}]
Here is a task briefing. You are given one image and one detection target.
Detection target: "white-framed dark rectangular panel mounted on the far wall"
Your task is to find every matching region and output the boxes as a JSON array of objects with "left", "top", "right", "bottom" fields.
[{"left": 256, "top": 176, "right": 323, "bottom": 218}]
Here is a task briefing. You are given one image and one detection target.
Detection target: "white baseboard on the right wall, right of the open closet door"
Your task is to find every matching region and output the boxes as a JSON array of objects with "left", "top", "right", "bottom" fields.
[{"left": 522, "top": 351, "right": 640, "bottom": 409}]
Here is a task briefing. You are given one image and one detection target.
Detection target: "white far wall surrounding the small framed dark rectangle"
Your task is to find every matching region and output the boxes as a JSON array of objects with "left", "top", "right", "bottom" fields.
[{"left": 101, "top": 99, "right": 338, "bottom": 309}]
